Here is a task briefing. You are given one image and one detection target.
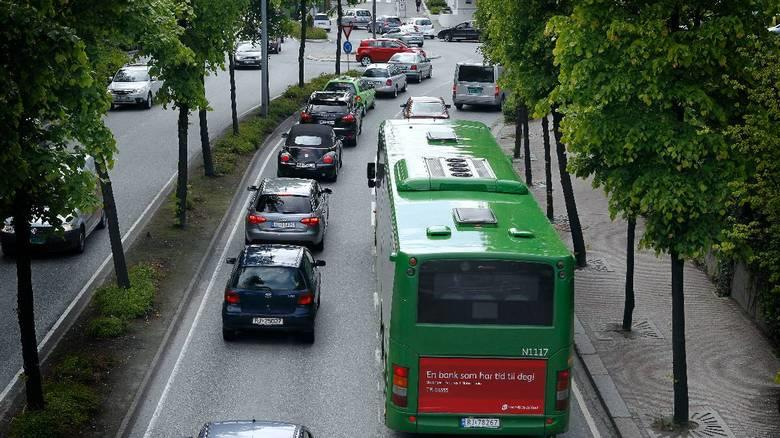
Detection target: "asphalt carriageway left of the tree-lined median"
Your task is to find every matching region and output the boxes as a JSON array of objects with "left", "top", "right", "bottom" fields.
[{"left": 0, "top": 34, "right": 354, "bottom": 401}]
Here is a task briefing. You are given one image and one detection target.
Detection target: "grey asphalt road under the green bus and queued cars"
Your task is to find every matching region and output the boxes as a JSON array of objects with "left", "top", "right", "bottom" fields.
[{"left": 129, "top": 15, "right": 611, "bottom": 438}]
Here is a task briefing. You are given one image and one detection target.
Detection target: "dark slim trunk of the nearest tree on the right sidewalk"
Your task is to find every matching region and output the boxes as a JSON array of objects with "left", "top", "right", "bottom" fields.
[{"left": 671, "top": 252, "right": 688, "bottom": 425}]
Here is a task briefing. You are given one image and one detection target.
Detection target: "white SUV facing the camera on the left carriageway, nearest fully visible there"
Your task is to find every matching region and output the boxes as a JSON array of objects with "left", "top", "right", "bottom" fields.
[{"left": 108, "top": 65, "right": 162, "bottom": 109}]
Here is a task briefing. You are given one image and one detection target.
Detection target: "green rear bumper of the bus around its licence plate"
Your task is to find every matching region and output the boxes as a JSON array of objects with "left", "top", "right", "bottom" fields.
[{"left": 385, "top": 405, "right": 569, "bottom": 436}]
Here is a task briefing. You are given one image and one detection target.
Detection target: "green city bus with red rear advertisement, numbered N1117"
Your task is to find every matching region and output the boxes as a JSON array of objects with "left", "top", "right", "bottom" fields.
[{"left": 367, "top": 119, "right": 574, "bottom": 436}]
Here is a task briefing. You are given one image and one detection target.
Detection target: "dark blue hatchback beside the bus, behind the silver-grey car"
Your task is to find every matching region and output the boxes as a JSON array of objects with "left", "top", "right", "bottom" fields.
[{"left": 222, "top": 245, "right": 325, "bottom": 343}]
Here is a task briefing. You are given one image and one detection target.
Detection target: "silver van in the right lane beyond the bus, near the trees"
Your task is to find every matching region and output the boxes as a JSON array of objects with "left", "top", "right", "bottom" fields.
[{"left": 452, "top": 62, "right": 506, "bottom": 111}]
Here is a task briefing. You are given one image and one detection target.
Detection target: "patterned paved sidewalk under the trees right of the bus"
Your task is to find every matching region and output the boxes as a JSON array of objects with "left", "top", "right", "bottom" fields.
[{"left": 493, "top": 115, "right": 780, "bottom": 437}]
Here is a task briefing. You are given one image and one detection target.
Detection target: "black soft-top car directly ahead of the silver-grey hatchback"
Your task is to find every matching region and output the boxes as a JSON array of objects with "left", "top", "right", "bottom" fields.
[{"left": 276, "top": 123, "right": 343, "bottom": 182}]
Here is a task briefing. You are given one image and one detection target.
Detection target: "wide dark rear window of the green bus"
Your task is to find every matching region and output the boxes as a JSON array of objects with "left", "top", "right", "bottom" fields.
[{"left": 417, "top": 260, "right": 555, "bottom": 326}]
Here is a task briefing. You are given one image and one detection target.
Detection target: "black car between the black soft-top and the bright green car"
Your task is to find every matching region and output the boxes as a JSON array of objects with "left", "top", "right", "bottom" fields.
[{"left": 300, "top": 91, "right": 363, "bottom": 146}]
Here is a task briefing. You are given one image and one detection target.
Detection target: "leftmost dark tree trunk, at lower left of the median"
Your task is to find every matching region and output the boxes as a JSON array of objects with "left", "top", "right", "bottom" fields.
[{"left": 13, "top": 189, "right": 44, "bottom": 411}]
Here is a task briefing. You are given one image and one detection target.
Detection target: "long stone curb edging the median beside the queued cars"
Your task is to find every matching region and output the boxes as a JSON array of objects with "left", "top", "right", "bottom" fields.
[{"left": 115, "top": 106, "right": 297, "bottom": 438}]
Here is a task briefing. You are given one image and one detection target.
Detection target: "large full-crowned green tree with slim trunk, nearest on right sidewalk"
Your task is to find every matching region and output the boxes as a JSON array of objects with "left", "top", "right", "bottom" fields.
[{"left": 552, "top": 0, "right": 772, "bottom": 424}]
